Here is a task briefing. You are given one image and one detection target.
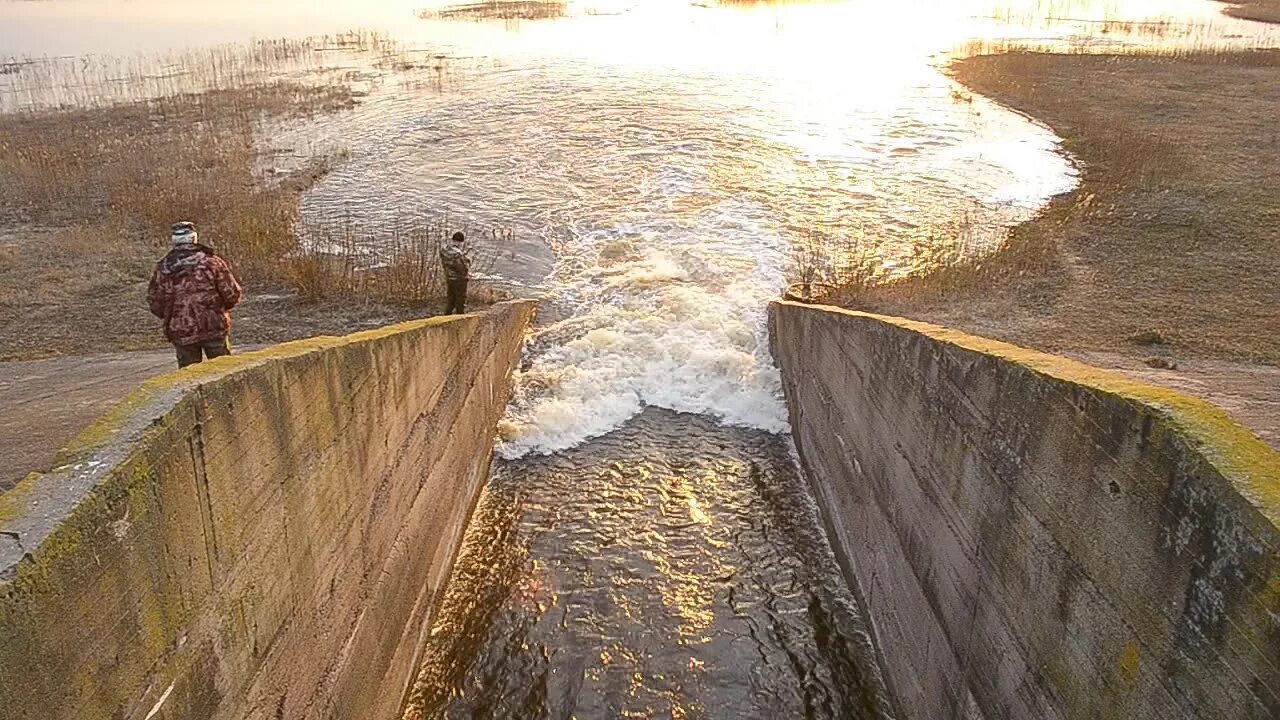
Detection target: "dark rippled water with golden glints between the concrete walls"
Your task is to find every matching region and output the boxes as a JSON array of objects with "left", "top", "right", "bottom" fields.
[{"left": 413, "top": 410, "right": 884, "bottom": 720}]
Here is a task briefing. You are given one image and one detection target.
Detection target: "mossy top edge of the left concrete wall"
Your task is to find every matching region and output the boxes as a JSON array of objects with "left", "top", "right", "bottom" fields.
[{"left": 0, "top": 300, "right": 538, "bottom": 579}]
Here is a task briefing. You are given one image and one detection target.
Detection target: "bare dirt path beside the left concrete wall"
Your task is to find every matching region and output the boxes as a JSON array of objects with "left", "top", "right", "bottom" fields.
[{"left": 0, "top": 350, "right": 175, "bottom": 492}]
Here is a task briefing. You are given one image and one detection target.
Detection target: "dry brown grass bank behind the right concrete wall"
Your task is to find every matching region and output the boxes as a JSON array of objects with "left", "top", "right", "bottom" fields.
[{"left": 863, "top": 51, "right": 1280, "bottom": 364}]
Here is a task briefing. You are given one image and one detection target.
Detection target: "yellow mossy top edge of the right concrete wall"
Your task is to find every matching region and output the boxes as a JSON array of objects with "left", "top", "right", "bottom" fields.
[{"left": 771, "top": 300, "right": 1280, "bottom": 530}]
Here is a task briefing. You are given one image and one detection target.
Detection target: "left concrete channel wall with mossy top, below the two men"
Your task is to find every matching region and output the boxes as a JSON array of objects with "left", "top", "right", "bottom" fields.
[{"left": 0, "top": 302, "right": 534, "bottom": 720}]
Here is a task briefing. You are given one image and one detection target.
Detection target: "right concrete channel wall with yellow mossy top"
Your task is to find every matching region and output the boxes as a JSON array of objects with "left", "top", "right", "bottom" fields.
[{"left": 771, "top": 304, "right": 1280, "bottom": 720}]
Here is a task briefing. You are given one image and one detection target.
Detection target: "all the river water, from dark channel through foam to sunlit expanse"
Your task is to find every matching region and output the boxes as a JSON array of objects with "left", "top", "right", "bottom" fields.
[{"left": 0, "top": 0, "right": 1276, "bottom": 719}]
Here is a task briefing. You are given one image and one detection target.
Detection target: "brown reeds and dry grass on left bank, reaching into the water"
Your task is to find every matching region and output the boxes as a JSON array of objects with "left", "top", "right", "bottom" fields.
[{"left": 0, "top": 32, "right": 491, "bottom": 304}]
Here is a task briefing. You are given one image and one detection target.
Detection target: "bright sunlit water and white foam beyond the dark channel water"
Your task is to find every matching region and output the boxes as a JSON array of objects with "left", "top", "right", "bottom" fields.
[{"left": 0, "top": 0, "right": 1272, "bottom": 448}]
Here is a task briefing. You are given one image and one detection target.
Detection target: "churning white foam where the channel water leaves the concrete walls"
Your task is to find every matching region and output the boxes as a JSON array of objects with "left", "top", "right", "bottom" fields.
[{"left": 499, "top": 201, "right": 787, "bottom": 457}]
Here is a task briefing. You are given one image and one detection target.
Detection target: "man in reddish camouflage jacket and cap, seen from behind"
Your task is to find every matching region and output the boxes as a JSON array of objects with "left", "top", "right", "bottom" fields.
[{"left": 147, "top": 223, "right": 241, "bottom": 368}]
